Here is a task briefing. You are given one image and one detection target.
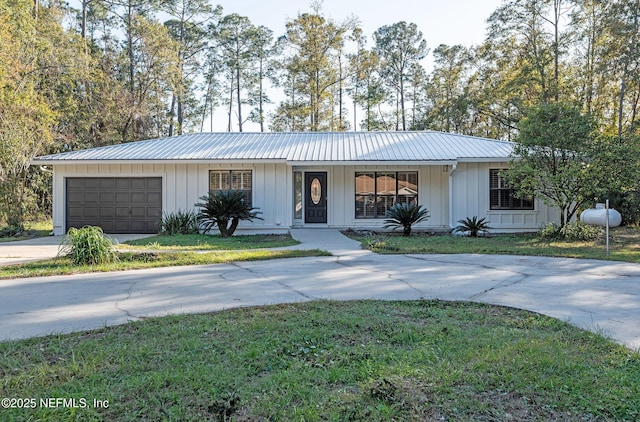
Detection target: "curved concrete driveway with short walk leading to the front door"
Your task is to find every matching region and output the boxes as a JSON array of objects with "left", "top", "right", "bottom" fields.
[{"left": 0, "top": 229, "right": 640, "bottom": 349}]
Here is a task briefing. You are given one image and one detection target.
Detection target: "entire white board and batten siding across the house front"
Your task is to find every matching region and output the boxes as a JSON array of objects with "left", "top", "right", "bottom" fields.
[{"left": 53, "top": 163, "right": 558, "bottom": 234}]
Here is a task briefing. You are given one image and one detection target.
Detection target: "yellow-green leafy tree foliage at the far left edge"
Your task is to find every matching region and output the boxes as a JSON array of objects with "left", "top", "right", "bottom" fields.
[{"left": 0, "top": 0, "right": 76, "bottom": 227}]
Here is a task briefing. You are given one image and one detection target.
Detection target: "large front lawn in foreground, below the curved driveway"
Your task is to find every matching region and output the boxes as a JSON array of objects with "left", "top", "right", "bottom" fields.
[{"left": 0, "top": 301, "right": 640, "bottom": 421}]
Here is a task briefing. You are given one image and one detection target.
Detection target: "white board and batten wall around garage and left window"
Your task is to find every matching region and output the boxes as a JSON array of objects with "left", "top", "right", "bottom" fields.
[{"left": 53, "top": 163, "right": 293, "bottom": 235}]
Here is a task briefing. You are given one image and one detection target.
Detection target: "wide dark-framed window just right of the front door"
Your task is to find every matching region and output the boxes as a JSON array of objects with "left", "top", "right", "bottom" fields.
[{"left": 355, "top": 171, "right": 418, "bottom": 218}]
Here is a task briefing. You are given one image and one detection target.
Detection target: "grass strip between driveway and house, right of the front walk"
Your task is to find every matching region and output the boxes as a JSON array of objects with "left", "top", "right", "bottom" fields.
[{"left": 349, "top": 227, "right": 640, "bottom": 263}]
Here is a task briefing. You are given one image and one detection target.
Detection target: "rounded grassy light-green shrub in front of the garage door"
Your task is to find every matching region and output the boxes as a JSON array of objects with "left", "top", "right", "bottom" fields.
[{"left": 58, "top": 226, "right": 118, "bottom": 265}]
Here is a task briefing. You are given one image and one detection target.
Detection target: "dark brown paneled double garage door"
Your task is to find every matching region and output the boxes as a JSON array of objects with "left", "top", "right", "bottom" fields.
[{"left": 65, "top": 177, "right": 162, "bottom": 233}]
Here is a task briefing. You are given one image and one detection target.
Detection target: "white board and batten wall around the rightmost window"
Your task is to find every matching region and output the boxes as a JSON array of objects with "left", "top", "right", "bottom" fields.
[{"left": 451, "top": 162, "right": 558, "bottom": 232}]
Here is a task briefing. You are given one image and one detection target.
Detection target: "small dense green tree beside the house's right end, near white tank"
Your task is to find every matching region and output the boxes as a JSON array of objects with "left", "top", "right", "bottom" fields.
[{"left": 505, "top": 103, "right": 610, "bottom": 227}]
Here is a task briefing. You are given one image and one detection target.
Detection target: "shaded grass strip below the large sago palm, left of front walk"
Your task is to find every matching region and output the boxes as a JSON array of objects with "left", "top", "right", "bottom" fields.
[{"left": 119, "top": 234, "right": 300, "bottom": 251}]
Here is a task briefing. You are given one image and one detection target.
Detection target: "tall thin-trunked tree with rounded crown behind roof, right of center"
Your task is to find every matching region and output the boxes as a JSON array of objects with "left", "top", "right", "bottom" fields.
[{"left": 373, "top": 21, "right": 428, "bottom": 130}]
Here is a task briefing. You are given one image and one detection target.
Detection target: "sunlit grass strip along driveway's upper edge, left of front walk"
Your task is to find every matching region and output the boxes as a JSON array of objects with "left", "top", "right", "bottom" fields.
[{"left": 0, "top": 250, "right": 329, "bottom": 279}]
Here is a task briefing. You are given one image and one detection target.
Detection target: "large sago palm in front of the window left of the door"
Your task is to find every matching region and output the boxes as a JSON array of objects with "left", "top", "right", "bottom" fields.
[{"left": 195, "top": 190, "right": 262, "bottom": 237}]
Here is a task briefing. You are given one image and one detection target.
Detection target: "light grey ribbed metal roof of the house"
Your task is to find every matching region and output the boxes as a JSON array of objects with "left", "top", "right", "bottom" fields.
[{"left": 34, "top": 131, "right": 512, "bottom": 164}]
